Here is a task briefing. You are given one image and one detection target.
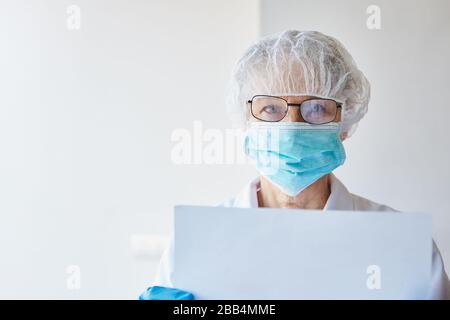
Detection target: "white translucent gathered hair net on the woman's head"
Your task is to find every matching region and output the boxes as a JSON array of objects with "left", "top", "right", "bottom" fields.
[{"left": 227, "top": 30, "right": 370, "bottom": 137}]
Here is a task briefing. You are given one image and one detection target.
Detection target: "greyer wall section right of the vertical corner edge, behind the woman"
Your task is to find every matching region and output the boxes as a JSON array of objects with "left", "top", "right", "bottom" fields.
[{"left": 261, "top": 0, "right": 450, "bottom": 270}]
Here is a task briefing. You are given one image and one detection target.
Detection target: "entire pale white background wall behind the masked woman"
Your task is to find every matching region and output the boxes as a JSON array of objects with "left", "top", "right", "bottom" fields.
[{"left": 0, "top": 0, "right": 450, "bottom": 298}]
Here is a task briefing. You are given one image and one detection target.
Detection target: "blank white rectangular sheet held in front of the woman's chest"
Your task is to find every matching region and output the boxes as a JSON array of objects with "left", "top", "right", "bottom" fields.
[{"left": 173, "top": 206, "right": 432, "bottom": 299}]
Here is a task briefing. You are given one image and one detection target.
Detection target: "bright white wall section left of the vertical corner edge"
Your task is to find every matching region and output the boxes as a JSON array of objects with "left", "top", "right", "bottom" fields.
[{"left": 0, "top": 0, "right": 258, "bottom": 298}]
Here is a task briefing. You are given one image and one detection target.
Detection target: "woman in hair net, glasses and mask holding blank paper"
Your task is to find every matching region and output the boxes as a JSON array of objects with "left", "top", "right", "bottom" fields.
[{"left": 141, "top": 31, "right": 450, "bottom": 299}]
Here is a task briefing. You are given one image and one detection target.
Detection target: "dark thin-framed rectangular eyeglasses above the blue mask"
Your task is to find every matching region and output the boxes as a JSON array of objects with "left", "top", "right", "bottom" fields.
[{"left": 247, "top": 95, "right": 342, "bottom": 124}]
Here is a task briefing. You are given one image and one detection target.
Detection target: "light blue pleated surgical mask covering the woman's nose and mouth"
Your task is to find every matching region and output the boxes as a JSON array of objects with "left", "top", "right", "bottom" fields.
[{"left": 244, "top": 122, "right": 345, "bottom": 196}]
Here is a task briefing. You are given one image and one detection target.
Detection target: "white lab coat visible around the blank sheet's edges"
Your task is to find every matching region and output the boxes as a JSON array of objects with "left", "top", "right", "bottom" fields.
[{"left": 153, "top": 174, "right": 450, "bottom": 299}]
